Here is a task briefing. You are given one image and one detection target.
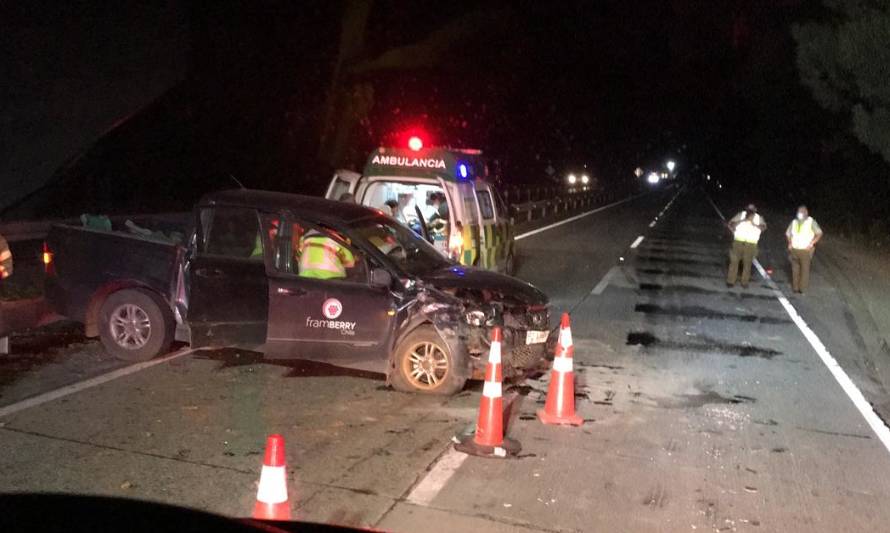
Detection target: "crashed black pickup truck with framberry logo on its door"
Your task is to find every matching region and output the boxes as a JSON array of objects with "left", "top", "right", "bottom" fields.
[{"left": 46, "top": 190, "right": 551, "bottom": 394}]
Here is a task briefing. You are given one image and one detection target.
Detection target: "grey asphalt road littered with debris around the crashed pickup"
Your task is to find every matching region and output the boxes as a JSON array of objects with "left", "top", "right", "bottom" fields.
[{"left": 0, "top": 185, "right": 890, "bottom": 532}]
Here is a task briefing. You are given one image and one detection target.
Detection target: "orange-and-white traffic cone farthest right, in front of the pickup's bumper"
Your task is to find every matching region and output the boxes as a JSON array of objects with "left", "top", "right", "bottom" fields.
[{"left": 538, "top": 313, "right": 584, "bottom": 426}]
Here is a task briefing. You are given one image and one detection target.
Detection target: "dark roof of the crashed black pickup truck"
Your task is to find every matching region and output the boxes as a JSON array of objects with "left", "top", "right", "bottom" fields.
[{"left": 200, "top": 189, "right": 380, "bottom": 223}]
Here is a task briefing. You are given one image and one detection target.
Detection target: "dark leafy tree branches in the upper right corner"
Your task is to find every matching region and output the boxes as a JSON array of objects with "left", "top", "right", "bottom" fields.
[{"left": 793, "top": 0, "right": 890, "bottom": 162}]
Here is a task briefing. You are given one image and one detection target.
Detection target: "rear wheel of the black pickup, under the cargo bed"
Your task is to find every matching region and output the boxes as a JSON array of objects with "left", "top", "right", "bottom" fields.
[{"left": 99, "top": 289, "right": 174, "bottom": 362}]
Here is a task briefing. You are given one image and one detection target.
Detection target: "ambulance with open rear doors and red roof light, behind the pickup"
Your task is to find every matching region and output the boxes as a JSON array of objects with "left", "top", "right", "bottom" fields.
[{"left": 326, "top": 137, "right": 515, "bottom": 274}]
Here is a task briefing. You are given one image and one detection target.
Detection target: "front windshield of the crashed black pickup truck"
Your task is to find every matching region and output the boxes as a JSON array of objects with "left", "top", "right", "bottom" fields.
[{"left": 350, "top": 216, "right": 452, "bottom": 276}]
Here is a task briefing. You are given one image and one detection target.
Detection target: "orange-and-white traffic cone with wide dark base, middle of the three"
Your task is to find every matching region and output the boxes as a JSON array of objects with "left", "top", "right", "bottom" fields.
[{"left": 454, "top": 327, "right": 521, "bottom": 457}]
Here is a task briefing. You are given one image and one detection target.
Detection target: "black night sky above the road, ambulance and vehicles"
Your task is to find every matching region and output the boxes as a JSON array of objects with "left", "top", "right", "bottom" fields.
[{"left": 0, "top": 0, "right": 886, "bottom": 231}]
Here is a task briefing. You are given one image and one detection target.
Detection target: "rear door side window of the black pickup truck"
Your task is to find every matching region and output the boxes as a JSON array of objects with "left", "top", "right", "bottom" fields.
[{"left": 198, "top": 207, "right": 263, "bottom": 261}]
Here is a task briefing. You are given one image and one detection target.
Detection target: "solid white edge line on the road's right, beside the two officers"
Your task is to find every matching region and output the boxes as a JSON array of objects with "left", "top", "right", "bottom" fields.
[{"left": 708, "top": 196, "right": 890, "bottom": 452}]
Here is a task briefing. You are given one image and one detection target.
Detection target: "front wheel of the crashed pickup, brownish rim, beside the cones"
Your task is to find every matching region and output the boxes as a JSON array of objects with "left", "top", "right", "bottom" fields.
[{"left": 390, "top": 325, "right": 467, "bottom": 395}]
